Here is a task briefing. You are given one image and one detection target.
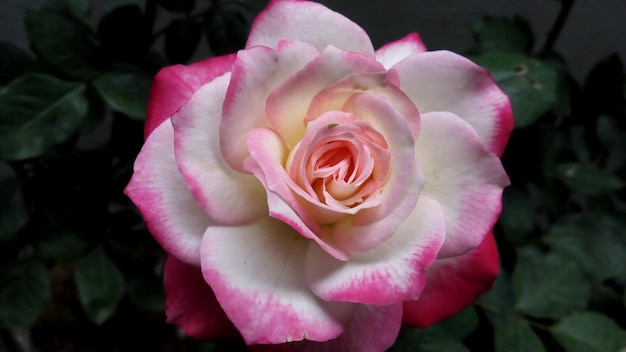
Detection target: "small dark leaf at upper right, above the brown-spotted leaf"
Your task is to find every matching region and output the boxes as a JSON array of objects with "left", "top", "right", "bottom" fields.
[{"left": 472, "top": 17, "right": 533, "bottom": 54}]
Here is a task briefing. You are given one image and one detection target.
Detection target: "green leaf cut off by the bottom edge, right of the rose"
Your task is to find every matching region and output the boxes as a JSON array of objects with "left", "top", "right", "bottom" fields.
[{"left": 492, "top": 314, "right": 546, "bottom": 352}]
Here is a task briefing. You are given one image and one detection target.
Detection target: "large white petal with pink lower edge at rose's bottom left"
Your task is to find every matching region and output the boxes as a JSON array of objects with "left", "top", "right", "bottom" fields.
[{"left": 201, "top": 217, "right": 356, "bottom": 345}]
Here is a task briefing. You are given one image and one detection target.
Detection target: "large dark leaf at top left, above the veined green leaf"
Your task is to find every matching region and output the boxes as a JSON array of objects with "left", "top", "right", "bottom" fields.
[{"left": 24, "top": 10, "right": 99, "bottom": 80}]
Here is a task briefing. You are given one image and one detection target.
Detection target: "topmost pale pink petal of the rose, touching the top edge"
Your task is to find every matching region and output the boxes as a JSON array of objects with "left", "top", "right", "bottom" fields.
[{"left": 246, "top": 0, "right": 374, "bottom": 57}]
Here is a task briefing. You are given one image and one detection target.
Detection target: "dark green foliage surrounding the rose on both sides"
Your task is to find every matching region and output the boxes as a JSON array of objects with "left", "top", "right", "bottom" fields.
[{"left": 0, "top": 0, "right": 626, "bottom": 352}]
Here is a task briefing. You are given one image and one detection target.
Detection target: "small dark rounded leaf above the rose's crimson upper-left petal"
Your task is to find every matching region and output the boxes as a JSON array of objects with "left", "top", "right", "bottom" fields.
[{"left": 165, "top": 18, "right": 202, "bottom": 64}]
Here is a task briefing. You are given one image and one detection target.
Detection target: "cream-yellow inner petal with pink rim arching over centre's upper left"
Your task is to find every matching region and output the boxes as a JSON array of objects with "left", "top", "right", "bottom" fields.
[{"left": 266, "top": 46, "right": 384, "bottom": 146}]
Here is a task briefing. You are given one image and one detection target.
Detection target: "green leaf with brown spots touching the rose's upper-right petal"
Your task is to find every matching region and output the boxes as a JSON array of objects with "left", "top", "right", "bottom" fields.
[{"left": 472, "top": 53, "right": 557, "bottom": 128}]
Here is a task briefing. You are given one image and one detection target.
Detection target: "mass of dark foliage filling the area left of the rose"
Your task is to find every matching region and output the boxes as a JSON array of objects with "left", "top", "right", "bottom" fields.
[{"left": 0, "top": 0, "right": 263, "bottom": 351}]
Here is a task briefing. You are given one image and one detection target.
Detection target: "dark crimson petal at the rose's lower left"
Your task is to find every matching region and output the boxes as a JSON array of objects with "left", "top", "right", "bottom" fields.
[{"left": 163, "top": 256, "right": 239, "bottom": 340}]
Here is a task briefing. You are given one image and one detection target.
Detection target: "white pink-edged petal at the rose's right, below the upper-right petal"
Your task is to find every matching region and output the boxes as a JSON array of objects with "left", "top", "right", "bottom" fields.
[{"left": 416, "top": 112, "right": 509, "bottom": 258}]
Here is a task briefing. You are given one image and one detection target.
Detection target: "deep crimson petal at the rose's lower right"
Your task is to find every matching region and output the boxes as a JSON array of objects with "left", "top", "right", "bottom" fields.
[{"left": 403, "top": 234, "right": 500, "bottom": 328}]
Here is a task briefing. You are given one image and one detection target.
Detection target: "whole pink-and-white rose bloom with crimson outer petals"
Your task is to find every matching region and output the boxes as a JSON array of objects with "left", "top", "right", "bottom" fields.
[{"left": 126, "top": 0, "right": 513, "bottom": 351}]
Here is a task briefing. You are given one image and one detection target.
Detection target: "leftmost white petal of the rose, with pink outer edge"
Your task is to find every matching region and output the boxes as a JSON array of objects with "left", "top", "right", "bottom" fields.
[{"left": 124, "top": 120, "right": 207, "bottom": 265}]
